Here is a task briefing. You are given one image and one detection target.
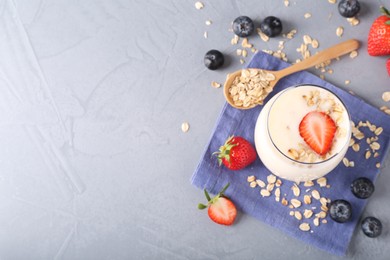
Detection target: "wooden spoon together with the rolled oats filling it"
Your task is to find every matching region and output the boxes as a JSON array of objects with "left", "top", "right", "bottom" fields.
[{"left": 224, "top": 39, "right": 359, "bottom": 109}]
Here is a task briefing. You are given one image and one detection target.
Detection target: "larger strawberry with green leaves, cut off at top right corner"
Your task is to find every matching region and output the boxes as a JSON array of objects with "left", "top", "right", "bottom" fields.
[{"left": 367, "top": 6, "right": 390, "bottom": 56}]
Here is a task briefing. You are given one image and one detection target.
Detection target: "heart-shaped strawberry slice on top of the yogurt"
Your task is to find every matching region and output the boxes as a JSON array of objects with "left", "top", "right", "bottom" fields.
[{"left": 299, "top": 111, "right": 336, "bottom": 155}]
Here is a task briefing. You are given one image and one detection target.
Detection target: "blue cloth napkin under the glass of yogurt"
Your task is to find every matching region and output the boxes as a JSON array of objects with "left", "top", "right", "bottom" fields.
[{"left": 191, "top": 52, "right": 390, "bottom": 255}]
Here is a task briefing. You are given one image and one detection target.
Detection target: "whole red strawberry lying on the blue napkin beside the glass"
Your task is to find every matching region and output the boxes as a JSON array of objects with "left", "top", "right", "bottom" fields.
[{"left": 214, "top": 136, "right": 256, "bottom": 170}]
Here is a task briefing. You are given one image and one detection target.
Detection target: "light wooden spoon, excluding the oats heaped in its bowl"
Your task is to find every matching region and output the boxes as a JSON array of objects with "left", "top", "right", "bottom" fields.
[{"left": 224, "top": 39, "right": 359, "bottom": 109}]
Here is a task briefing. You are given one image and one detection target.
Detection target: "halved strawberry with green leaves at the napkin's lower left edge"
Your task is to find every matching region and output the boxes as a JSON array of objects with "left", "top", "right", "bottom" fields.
[{"left": 198, "top": 183, "right": 237, "bottom": 226}]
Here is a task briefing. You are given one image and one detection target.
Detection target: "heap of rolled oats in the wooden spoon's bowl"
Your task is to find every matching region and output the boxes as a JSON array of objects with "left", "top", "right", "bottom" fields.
[{"left": 229, "top": 69, "right": 275, "bottom": 108}]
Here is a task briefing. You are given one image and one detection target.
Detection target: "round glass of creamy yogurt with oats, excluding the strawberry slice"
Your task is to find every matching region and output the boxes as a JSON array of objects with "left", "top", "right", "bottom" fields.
[{"left": 254, "top": 85, "right": 351, "bottom": 182}]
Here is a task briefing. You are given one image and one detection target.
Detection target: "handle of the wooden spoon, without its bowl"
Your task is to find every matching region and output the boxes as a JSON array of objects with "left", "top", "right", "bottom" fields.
[{"left": 278, "top": 39, "right": 359, "bottom": 78}]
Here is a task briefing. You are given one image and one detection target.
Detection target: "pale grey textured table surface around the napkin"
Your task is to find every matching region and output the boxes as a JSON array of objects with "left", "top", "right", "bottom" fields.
[{"left": 0, "top": 0, "right": 390, "bottom": 259}]
